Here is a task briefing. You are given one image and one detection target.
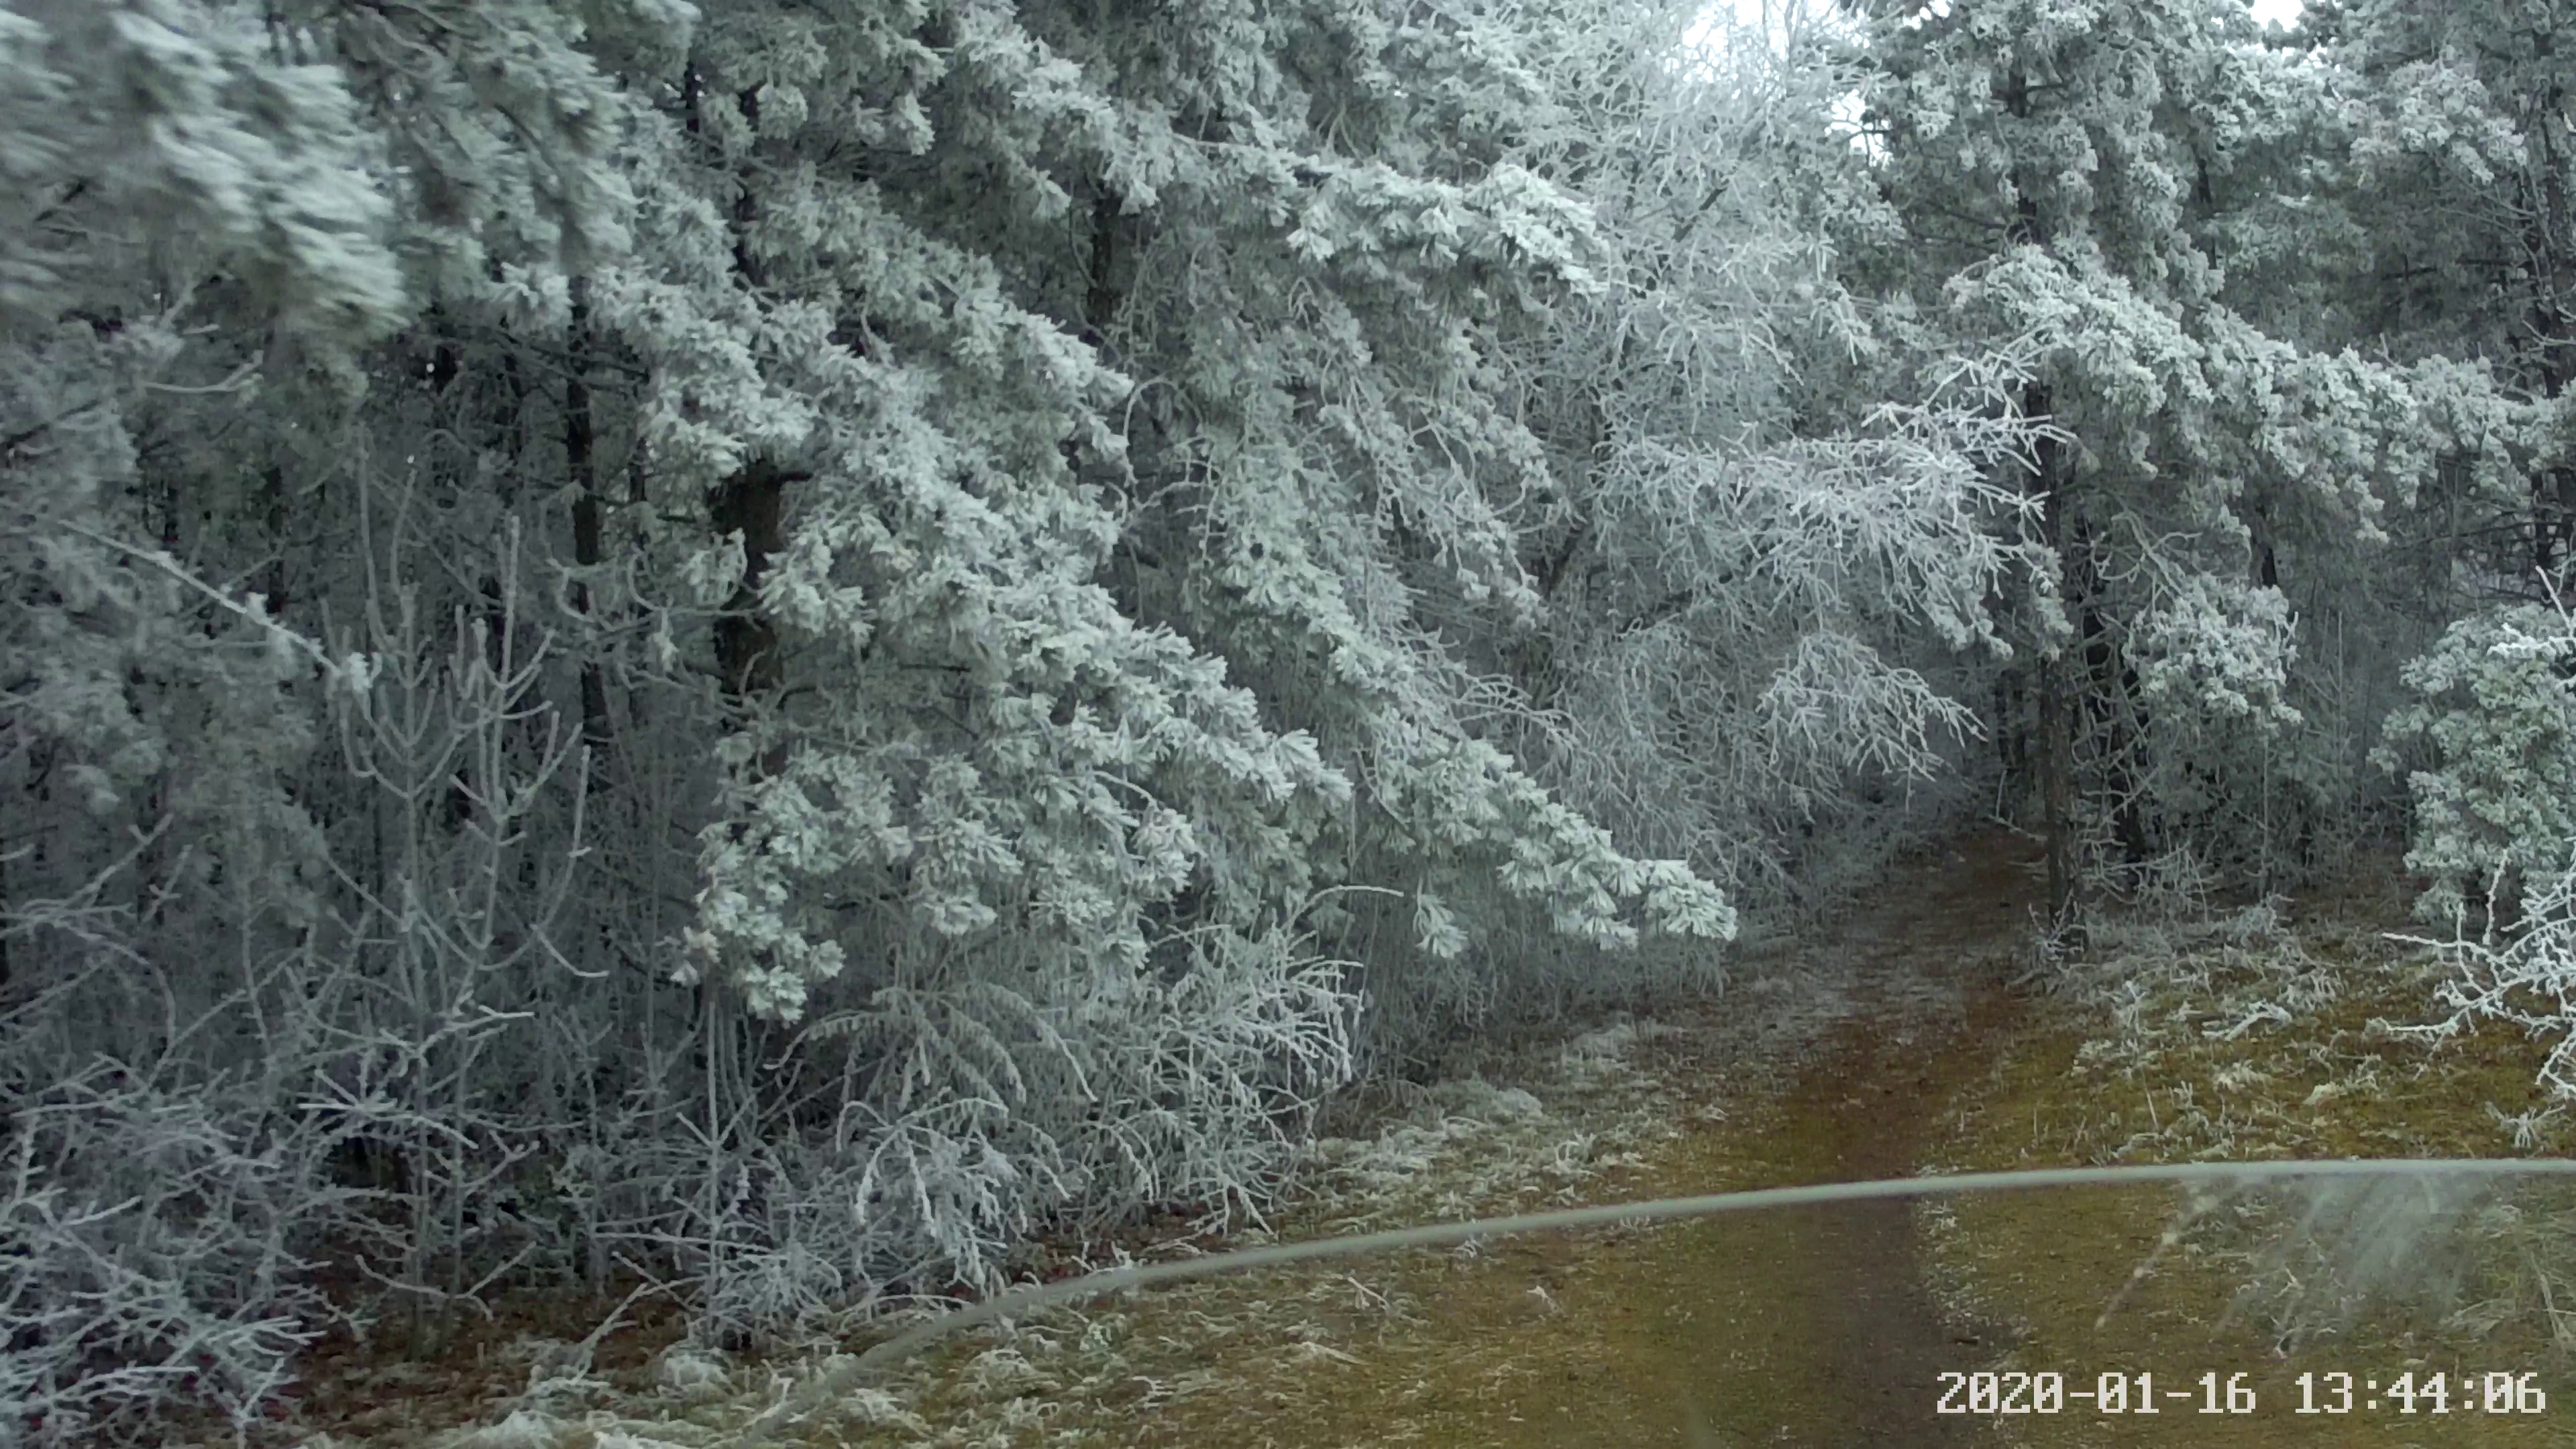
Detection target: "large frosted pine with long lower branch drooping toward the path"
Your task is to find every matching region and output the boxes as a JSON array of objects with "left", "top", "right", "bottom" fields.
[{"left": 618, "top": 5, "right": 1729, "bottom": 1299}]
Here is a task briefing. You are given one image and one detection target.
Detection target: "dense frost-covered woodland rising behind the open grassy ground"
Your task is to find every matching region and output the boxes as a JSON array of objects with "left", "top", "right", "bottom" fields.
[{"left": 25, "top": 0, "right": 2576, "bottom": 1441}]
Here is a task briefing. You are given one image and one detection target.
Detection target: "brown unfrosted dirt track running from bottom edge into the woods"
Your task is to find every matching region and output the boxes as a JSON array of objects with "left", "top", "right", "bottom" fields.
[{"left": 1066, "top": 833, "right": 2030, "bottom": 1449}]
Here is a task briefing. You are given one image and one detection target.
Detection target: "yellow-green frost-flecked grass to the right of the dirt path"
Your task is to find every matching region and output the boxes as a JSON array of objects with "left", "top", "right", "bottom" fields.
[{"left": 1924, "top": 840, "right": 2576, "bottom": 1449}]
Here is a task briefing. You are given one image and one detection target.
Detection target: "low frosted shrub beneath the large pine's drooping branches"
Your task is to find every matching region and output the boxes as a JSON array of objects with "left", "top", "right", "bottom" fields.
[{"left": 816, "top": 912, "right": 1358, "bottom": 1281}]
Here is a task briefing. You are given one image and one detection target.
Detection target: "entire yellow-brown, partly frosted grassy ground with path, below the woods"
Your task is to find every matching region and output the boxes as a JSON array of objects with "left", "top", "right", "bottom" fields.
[{"left": 276, "top": 835, "right": 2576, "bottom": 1449}]
